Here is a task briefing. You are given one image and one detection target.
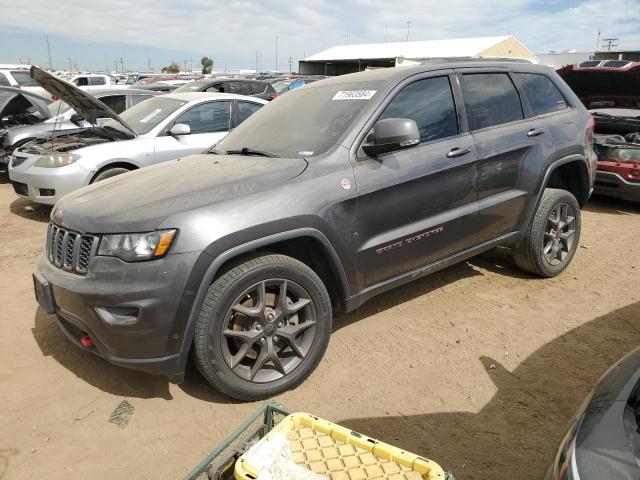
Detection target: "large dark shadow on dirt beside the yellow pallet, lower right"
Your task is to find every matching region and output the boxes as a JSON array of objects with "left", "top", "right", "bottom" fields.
[{"left": 336, "top": 302, "right": 640, "bottom": 480}]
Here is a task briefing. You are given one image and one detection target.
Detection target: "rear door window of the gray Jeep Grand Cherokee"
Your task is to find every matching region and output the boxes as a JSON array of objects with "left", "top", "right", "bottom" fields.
[{"left": 460, "top": 73, "right": 524, "bottom": 131}]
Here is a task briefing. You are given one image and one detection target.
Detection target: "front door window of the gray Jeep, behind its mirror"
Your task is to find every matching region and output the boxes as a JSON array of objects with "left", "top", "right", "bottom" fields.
[{"left": 380, "top": 77, "right": 458, "bottom": 142}]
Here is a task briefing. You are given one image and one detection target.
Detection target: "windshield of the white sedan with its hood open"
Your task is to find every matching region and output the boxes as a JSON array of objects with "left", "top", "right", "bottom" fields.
[{"left": 102, "top": 97, "right": 187, "bottom": 135}]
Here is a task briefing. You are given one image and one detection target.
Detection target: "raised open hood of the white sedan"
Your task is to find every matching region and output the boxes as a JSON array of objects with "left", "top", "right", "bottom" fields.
[{"left": 31, "top": 66, "right": 137, "bottom": 138}]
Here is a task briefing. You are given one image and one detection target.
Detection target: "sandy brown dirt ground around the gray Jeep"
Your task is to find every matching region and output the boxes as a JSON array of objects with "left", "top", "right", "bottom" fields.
[{"left": 0, "top": 179, "right": 640, "bottom": 480}]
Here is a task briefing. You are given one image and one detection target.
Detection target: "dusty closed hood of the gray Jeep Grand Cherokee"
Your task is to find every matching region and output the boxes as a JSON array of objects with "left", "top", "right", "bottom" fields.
[{"left": 51, "top": 154, "right": 307, "bottom": 233}]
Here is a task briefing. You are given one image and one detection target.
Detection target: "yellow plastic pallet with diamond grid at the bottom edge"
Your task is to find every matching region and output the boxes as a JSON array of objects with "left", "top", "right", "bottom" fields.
[{"left": 235, "top": 413, "right": 445, "bottom": 480}]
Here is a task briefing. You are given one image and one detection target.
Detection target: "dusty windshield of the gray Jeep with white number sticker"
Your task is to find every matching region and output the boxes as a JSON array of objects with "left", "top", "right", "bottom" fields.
[{"left": 215, "top": 82, "right": 383, "bottom": 158}]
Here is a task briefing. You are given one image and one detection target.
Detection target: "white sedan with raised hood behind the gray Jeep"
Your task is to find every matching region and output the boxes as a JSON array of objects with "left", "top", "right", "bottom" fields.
[{"left": 9, "top": 67, "right": 268, "bottom": 205}]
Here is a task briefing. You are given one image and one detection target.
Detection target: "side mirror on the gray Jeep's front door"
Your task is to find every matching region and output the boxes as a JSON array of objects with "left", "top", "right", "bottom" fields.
[{"left": 362, "top": 118, "right": 420, "bottom": 157}]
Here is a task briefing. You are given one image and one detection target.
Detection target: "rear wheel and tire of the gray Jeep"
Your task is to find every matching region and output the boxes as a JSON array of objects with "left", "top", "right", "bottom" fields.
[{"left": 513, "top": 188, "right": 581, "bottom": 278}]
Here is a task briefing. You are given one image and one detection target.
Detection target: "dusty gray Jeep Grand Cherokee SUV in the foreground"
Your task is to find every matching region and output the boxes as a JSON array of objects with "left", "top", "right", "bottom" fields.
[{"left": 34, "top": 61, "right": 595, "bottom": 399}]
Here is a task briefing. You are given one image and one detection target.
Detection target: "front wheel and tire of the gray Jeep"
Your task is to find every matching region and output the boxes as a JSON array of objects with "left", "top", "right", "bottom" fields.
[{"left": 194, "top": 254, "right": 332, "bottom": 400}]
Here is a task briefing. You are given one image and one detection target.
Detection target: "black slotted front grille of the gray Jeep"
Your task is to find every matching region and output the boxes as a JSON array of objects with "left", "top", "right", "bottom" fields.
[{"left": 47, "top": 223, "right": 98, "bottom": 275}]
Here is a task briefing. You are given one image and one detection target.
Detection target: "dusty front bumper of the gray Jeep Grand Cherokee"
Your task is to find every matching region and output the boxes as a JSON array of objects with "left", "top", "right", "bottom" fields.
[{"left": 34, "top": 252, "right": 198, "bottom": 378}]
